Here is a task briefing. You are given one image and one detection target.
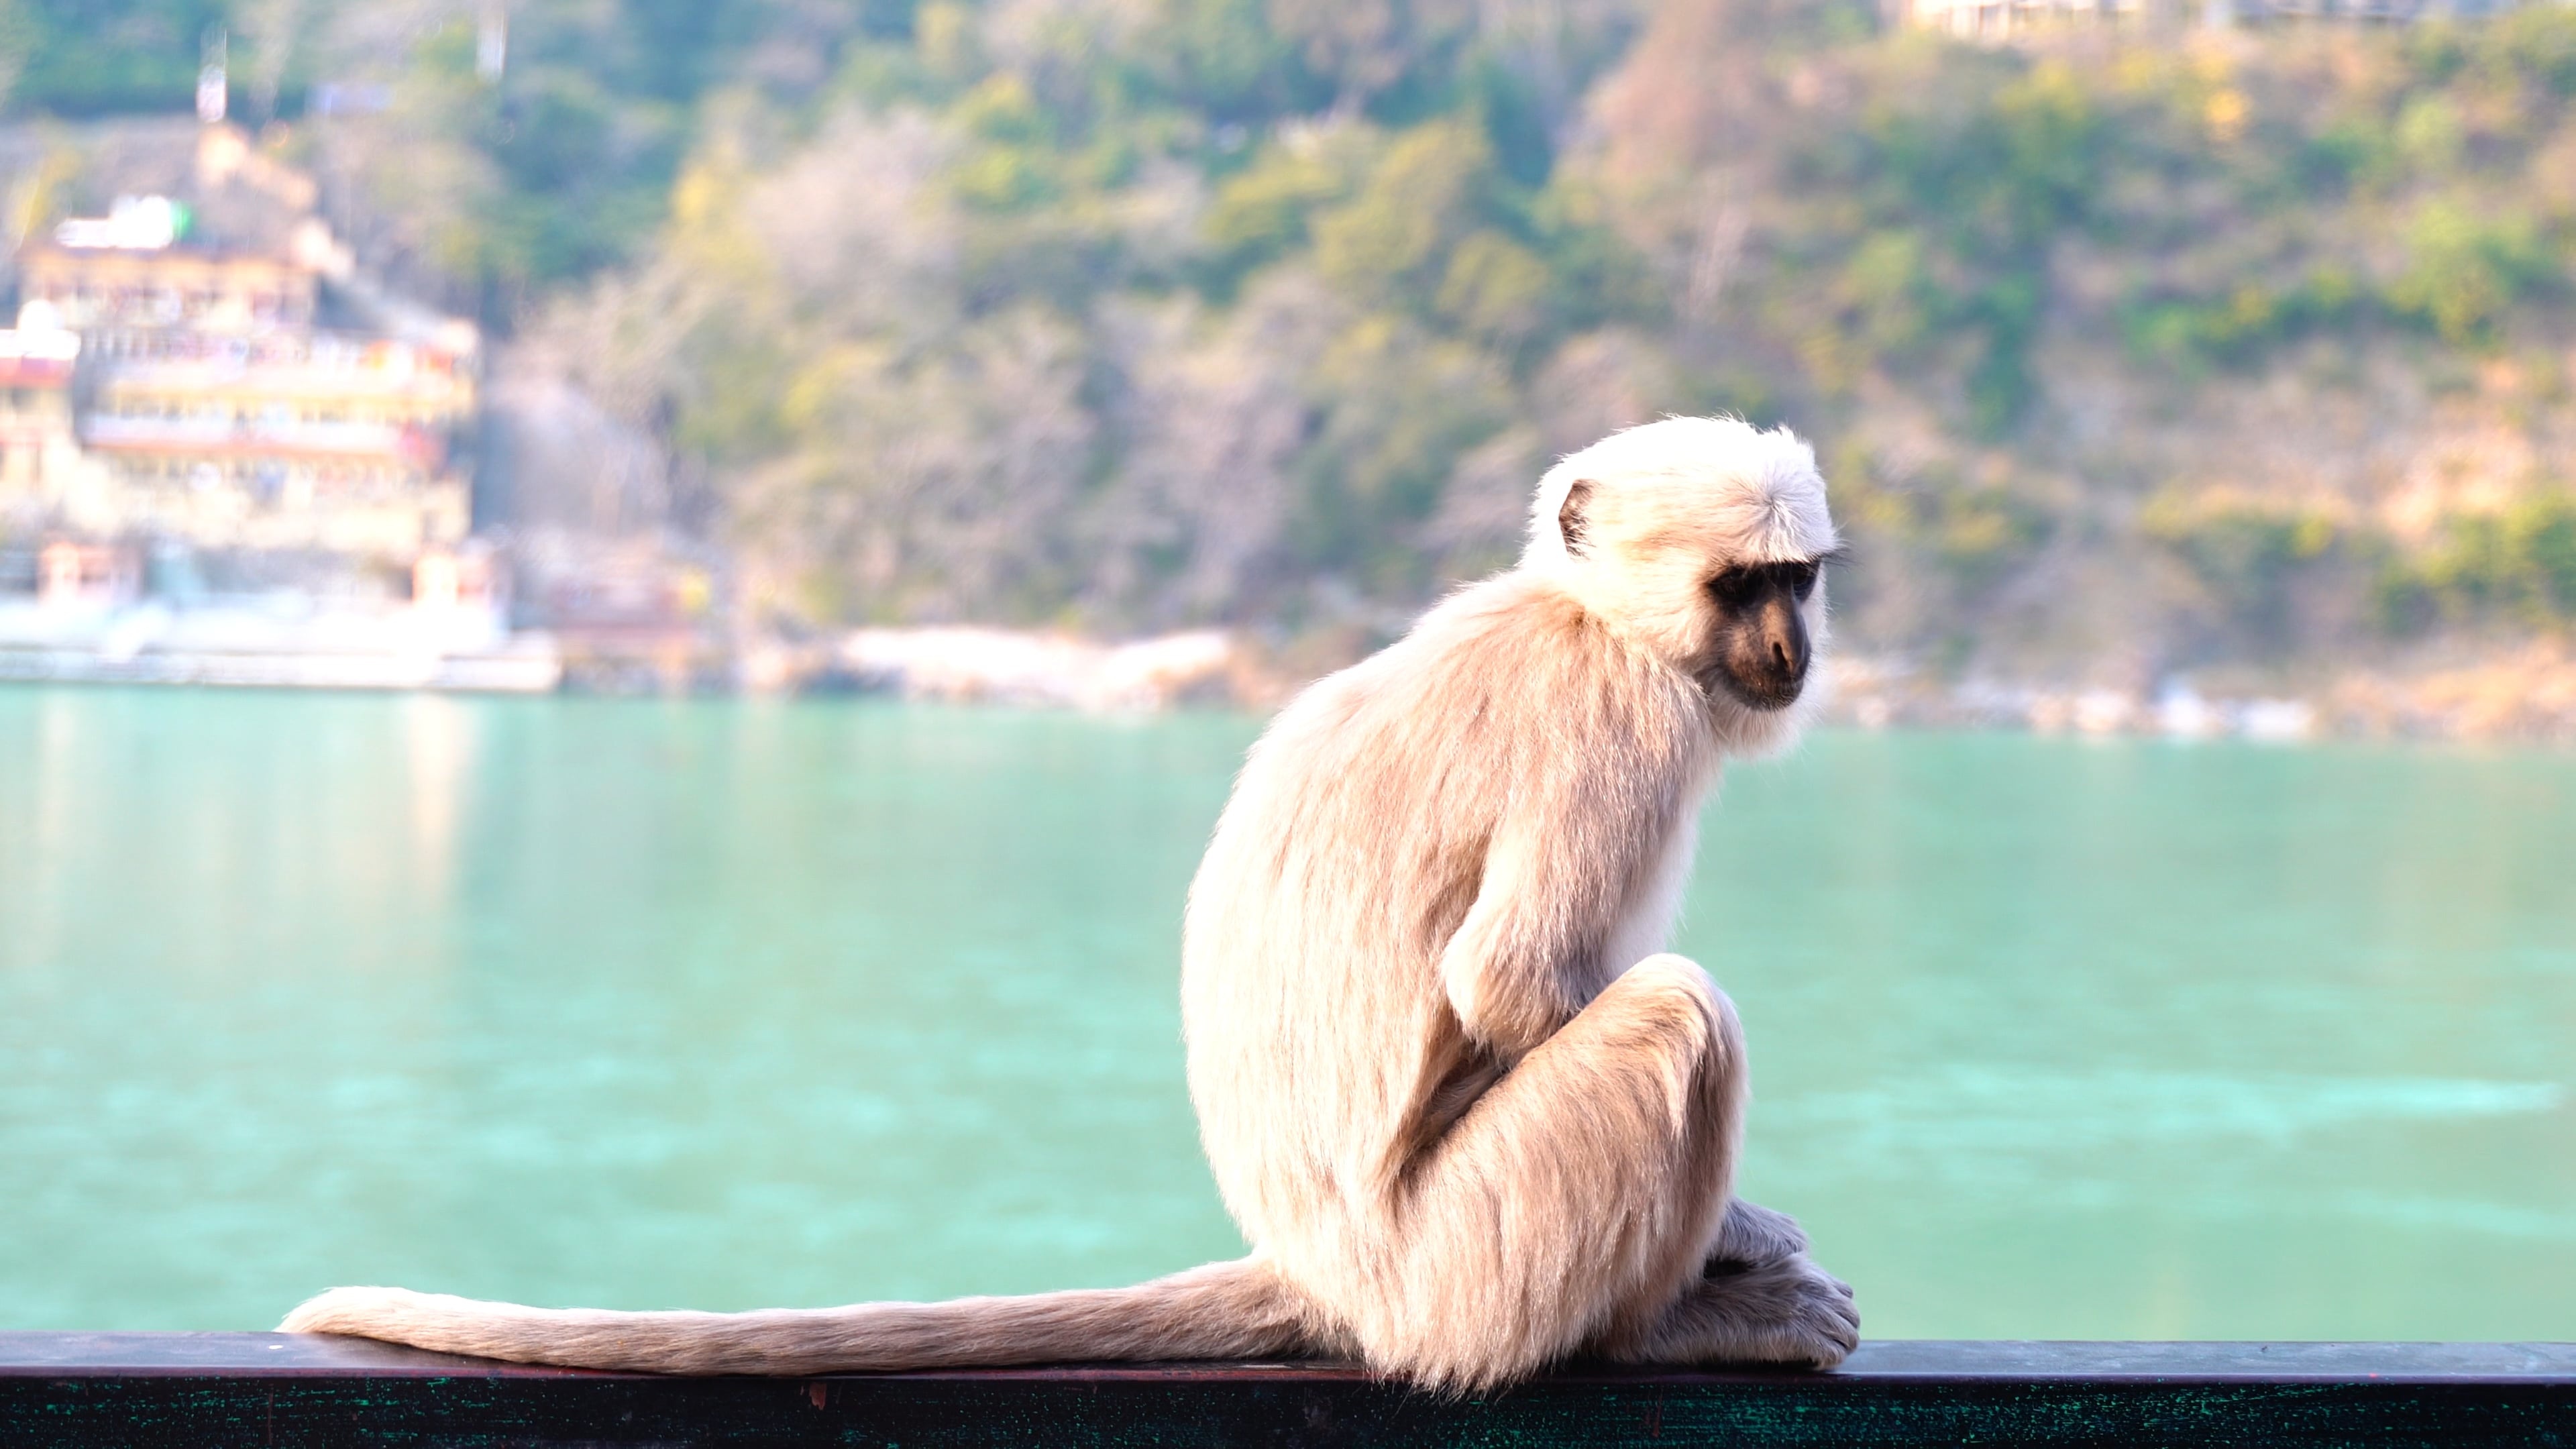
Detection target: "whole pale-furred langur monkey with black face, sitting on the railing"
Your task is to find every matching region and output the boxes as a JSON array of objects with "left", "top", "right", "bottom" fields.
[{"left": 283, "top": 418, "right": 1860, "bottom": 1392}]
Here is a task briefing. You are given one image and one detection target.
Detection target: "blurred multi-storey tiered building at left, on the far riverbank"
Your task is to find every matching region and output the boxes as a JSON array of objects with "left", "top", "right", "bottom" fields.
[{"left": 0, "top": 123, "right": 559, "bottom": 686}]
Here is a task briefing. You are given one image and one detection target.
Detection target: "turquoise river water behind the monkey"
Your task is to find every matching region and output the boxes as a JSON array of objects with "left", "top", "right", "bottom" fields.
[{"left": 0, "top": 688, "right": 2576, "bottom": 1338}]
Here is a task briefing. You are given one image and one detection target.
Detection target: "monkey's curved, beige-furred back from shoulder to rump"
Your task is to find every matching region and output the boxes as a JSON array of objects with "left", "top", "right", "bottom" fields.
[{"left": 1183, "top": 572, "right": 1705, "bottom": 1258}]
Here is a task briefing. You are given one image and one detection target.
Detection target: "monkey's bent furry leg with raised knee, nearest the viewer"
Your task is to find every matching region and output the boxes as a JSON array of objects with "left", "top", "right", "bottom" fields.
[{"left": 1334, "top": 954, "right": 1842, "bottom": 1385}]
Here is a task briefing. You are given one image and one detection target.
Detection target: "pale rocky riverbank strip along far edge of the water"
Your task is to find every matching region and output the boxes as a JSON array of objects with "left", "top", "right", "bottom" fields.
[{"left": 0, "top": 608, "right": 2576, "bottom": 745}]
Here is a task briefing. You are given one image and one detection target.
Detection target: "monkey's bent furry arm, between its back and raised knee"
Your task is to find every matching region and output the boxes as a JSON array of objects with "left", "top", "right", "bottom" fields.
[{"left": 1440, "top": 750, "right": 1674, "bottom": 1060}]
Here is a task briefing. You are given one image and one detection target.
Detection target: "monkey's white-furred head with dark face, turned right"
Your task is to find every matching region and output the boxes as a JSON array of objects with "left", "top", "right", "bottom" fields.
[{"left": 1522, "top": 418, "right": 1842, "bottom": 748}]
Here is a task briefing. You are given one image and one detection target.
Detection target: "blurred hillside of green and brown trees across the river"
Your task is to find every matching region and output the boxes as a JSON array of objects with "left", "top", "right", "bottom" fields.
[{"left": 0, "top": 0, "right": 2576, "bottom": 730}]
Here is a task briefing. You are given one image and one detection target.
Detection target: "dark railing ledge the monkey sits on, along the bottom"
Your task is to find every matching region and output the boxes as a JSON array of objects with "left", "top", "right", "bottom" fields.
[{"left": 0, "top": 1333, "right": 2576, "bottom": 1449}]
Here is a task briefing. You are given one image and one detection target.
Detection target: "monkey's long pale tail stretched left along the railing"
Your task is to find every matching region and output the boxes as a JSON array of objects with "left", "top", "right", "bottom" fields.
[{"left": 278, "top": 1258, "right": 1313, "bottom": 1375}]
